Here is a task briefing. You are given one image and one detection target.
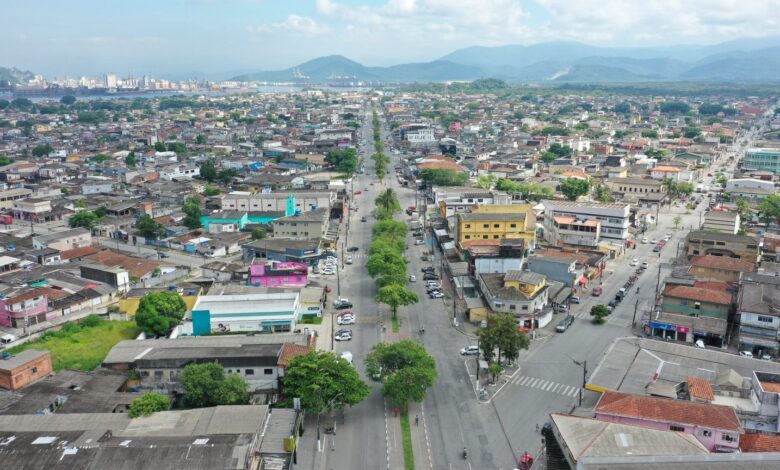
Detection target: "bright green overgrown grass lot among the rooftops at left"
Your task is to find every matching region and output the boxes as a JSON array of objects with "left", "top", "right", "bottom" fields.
[{"left": 8, "top": 317, "right": 141, "bottom": 371}]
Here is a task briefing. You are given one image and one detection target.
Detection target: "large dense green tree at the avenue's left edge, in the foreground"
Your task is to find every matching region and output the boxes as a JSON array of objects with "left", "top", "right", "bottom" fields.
[{"left": 282, "top": 350, "right": 371, "bottom": 414}]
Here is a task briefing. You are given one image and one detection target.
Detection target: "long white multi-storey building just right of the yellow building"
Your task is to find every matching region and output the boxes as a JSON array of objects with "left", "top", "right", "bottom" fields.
[{"left": 542, "top": 200, "right": 631, "bottom": 247}]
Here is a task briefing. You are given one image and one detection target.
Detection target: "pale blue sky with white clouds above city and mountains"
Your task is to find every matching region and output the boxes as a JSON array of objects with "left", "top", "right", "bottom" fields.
[{"left": 0, "top": 0, "right": 780, "bottom": 77}]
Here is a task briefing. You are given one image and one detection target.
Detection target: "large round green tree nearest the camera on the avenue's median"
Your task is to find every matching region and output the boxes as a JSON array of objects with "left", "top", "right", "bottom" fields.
[{"left": 365, "top": 339, "right": 438, "bottom": 408}]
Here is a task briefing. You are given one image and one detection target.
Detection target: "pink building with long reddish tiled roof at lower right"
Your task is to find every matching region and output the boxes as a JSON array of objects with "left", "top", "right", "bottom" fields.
[{"left": 595, "top": 391, "right": 744, "bottom": 452}]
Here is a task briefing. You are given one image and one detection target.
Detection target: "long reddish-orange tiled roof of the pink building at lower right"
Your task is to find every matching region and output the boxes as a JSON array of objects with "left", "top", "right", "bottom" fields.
[{"left": 595, "top": 391, "right": 742, "bottom": 432}]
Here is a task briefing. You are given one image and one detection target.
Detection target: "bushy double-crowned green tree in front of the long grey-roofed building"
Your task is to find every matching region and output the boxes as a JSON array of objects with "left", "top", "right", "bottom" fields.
[{"left": 181, "top": 361, "right": 249, "bottom": 408}]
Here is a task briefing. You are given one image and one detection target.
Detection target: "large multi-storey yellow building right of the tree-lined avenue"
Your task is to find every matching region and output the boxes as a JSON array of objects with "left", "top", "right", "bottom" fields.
[{"left": 458, "top": 204, "right": 536, "bottom": 247}]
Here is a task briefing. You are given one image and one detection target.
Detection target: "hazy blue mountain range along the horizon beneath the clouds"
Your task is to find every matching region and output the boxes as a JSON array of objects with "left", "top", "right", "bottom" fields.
[{"left": 232, "top": 36, "right": 780, "bottom": 83}]
